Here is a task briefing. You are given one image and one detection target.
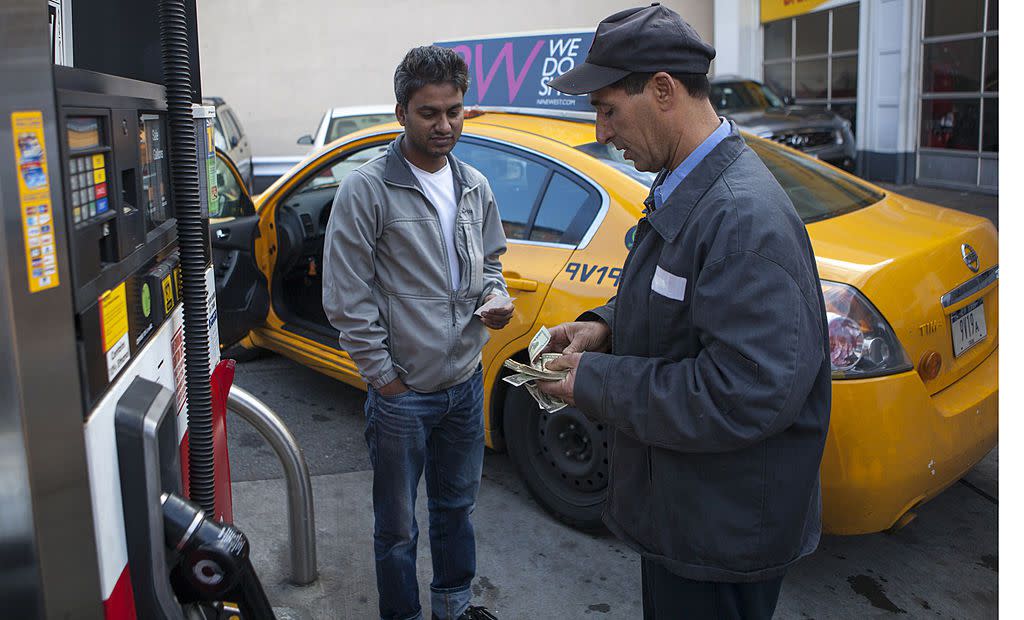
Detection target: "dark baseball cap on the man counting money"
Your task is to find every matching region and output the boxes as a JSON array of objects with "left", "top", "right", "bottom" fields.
[{"left": 550, "top": 2, "right": 715, "bottom": 94}]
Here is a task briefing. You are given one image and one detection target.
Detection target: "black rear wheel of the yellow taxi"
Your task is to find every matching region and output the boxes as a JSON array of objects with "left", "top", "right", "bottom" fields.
[{"left": 504, "top": 379, "right": 608, "bottom": 530}]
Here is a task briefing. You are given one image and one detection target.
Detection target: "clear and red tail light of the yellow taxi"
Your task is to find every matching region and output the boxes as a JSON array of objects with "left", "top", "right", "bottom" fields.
[{"left": 821, "top": 280, "right": 912, "bottom": 379}]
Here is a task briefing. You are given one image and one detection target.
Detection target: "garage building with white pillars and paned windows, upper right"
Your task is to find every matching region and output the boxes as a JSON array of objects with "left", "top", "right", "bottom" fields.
[{"left": 713, "top": 0, "right": 999, "bottom": 193}]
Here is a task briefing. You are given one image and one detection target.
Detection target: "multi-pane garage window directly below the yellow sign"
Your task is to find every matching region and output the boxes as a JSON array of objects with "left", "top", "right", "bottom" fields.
[{"left": 764, "top": 2, "right": 860, "bottom": 131}]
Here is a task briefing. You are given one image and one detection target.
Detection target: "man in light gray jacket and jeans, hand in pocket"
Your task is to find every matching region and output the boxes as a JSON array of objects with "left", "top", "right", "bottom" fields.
[{"left": 324, "top": 46, "right": 513, "bottom": 620}]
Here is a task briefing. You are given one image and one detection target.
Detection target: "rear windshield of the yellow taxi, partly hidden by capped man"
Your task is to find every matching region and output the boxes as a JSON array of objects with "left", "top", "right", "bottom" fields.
[{"left": 577, "top": 139, "right": 883, "bottom": 223}]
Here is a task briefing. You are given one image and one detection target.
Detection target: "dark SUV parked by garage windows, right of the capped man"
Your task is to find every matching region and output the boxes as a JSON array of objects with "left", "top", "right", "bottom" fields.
[{"left": 711, "top": 76, "right": 857, "bottom": 170}]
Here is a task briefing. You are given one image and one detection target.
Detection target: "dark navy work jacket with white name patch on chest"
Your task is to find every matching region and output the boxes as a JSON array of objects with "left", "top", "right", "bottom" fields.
[{"left": 573, "top": 124, "right": 831, "bottom": 582}]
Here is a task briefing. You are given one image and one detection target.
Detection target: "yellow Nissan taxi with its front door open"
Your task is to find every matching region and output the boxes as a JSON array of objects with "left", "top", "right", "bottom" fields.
[{"left": 212, "top": 112, "right": 998, "bottom": 534}]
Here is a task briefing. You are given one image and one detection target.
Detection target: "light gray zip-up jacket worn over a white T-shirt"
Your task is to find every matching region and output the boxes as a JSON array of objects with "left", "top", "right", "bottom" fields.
[{"left": 324, "top": 136, "right": 508, "bottom": 392}]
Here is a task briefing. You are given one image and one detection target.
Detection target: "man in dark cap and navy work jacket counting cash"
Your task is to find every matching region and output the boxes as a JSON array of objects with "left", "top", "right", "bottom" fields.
[{"left": 542, "top": 5, "right": 831, "bottom": 618}]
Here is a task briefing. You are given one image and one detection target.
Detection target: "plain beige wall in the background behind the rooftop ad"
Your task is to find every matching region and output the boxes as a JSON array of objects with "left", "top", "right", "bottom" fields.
[{"left": 199, "top": 0, "right": 714, "bottom": 156}]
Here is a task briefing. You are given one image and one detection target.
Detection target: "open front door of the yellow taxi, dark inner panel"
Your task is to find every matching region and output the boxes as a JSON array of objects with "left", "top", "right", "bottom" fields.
[{"left": 210, "top": 149, "right": 270, "bottom": 346}]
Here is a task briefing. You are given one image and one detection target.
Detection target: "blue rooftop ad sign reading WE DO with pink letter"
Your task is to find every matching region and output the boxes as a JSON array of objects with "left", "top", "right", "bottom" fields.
[{"left": 434, "top": 30, "right": 594, "bottom": 112}]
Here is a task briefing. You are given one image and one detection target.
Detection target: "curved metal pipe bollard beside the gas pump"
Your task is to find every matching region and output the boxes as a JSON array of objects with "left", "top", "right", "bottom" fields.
[{"left": 227, "top": 385, "right": 316, "bottom": 585}]
